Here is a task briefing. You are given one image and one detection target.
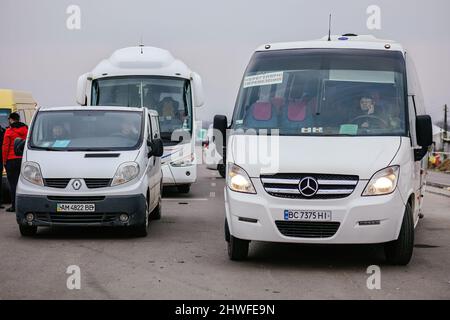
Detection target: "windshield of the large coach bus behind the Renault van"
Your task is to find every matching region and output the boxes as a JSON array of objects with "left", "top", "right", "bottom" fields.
[{"left": 92, "top": 76, "right": 192, "bottom": 144}]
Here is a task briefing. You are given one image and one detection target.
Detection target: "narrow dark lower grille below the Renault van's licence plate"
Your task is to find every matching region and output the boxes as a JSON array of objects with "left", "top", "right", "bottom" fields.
[{"left": 36, "top": 212, "right": 117, "bottom": 224}]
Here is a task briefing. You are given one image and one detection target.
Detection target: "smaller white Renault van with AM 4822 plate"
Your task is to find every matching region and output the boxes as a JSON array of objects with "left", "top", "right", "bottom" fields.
[{"left": 16, "top": 107, "right": 163, "bottom": 236}]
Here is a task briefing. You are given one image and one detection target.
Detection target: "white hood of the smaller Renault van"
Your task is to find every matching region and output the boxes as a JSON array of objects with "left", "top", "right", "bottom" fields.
[{"left": 24, "top": 149, "right": 139, "bottom": 179}]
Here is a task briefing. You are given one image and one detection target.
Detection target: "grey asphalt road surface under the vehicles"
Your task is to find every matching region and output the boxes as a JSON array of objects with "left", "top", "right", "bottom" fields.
[{"left": 0, "top": 167, "right": 450, "bottom": 300}]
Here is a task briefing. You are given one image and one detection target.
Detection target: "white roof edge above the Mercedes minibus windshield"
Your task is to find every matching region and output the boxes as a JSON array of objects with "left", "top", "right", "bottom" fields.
[{"left": 256, "top": 34, "right": 404, "bottom": 53}]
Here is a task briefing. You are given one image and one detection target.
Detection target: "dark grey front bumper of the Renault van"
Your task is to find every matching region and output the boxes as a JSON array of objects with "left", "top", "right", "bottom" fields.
[{"left": 16, "top": 194, "right": 146, "bottom": 227}]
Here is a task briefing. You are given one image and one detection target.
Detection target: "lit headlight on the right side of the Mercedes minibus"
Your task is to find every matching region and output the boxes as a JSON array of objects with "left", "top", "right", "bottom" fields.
[{"left": 362, "top": 166, "right": 400, "bottom": 196}]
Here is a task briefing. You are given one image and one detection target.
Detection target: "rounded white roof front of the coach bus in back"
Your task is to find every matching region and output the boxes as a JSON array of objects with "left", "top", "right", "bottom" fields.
[{"left": 92, "top": 46, "right": 192, "bottom": 79}]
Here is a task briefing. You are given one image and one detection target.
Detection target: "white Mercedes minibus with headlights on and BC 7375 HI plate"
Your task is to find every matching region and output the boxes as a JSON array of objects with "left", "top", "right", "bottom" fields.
[{"left": 214, "top": 34, "right": 432, "bottom": 265}]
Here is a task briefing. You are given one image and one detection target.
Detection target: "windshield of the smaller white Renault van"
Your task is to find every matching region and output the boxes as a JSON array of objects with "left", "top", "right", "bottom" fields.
[{"left": 30, "top": 110, "right": 143, "bottom": 151}]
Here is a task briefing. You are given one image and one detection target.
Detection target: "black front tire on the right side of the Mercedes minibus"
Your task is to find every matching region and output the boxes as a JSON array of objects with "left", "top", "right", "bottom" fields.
[{"left": 384, "top": 204, "right": 414, "bottom": 266}]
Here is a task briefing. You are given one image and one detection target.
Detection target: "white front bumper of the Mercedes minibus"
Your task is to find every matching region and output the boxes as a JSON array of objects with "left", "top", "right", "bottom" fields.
[{"left": 225, "top": 179, "right": 405, "bottom": 244}]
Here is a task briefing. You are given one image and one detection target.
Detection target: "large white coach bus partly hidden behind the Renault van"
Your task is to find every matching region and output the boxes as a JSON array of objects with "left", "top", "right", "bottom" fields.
[{"left": 77, "top": 46, "right": 204, "bottom": 193}]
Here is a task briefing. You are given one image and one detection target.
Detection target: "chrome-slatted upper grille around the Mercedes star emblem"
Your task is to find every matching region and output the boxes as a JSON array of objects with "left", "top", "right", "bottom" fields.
[{"left": 261, "top": 173, "right": 359, "bottom": 200}]
